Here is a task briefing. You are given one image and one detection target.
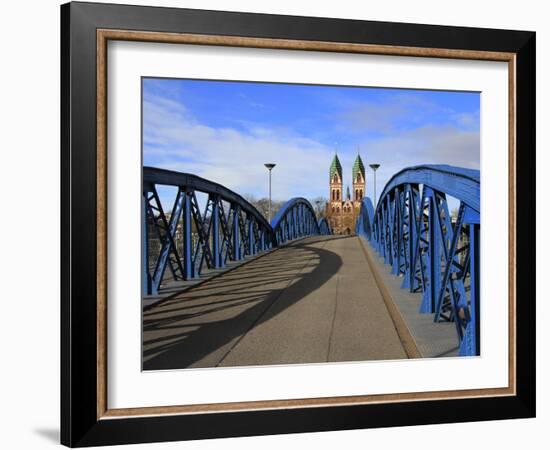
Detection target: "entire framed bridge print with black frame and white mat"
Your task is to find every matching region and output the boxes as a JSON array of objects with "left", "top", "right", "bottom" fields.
[{"left": 61, "top": 3, "right": 535, "bottom": 446}]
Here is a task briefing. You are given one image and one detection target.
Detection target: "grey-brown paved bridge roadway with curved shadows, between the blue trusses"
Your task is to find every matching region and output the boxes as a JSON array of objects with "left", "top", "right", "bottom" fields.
[{"left": 143, "top": 236, "right": 407, "bottom": 370}]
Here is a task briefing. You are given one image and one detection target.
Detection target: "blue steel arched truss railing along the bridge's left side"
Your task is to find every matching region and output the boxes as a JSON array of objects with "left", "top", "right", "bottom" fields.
[{"left": 141, "top": 167, "right": 330, "bottom": 295}]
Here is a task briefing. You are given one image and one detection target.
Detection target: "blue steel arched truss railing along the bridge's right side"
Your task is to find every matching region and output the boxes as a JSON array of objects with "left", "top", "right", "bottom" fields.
[{"left": 356, "top": 165, "right": 480, "bottom": 356}]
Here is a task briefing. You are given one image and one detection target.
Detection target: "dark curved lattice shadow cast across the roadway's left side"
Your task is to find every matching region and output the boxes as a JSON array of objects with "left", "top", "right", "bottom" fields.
[{"left": 143, "top": 237, "right": 346, "bottom": 370}]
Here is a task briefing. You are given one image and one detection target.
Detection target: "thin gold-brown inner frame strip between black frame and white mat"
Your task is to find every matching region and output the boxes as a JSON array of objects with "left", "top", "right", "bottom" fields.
[{"left": 97, "top": 29, "right": 516, "bottom": 419}]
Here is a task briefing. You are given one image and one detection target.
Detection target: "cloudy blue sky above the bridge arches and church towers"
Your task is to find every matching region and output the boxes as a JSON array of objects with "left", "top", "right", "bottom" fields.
[{"left": 143, "top": 78, "right": 480, "bottom": 204}]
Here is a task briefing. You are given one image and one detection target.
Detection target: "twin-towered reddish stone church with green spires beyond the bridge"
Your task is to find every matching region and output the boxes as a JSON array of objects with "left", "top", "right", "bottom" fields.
[{"left": 325, "top": 154, "right": 367, "bottom": 234}]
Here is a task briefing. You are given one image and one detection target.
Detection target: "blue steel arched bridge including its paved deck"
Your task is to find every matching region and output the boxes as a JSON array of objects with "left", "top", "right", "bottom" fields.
[{"left": 142, "top": 165, "right": 480, "bottom": 370}]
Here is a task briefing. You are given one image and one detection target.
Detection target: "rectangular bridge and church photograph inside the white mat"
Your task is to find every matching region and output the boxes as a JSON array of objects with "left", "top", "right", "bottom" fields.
[{"left": 141, "top": 76, "right": 483, "bottom": 371}]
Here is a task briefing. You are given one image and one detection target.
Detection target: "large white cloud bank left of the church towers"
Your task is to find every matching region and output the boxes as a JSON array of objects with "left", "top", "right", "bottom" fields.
[{"left": 143, "top": 91, "right": 332, "bottom": 200}]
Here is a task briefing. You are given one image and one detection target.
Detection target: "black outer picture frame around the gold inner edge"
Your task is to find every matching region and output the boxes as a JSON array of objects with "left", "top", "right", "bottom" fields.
[{"left": 61, "top": 2, "right": 536, "bottom": 447}]
